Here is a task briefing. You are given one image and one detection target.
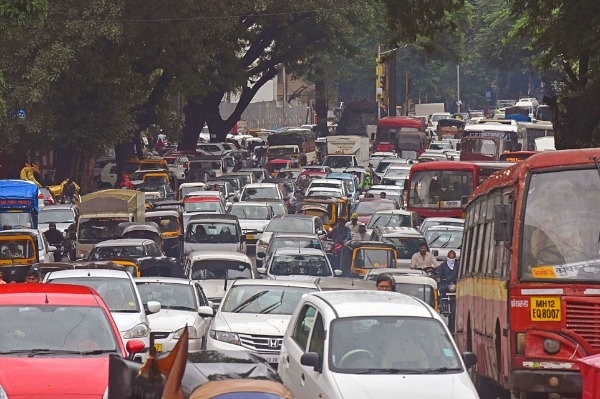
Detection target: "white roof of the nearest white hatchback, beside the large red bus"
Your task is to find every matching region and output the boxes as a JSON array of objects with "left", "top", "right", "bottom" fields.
[{"left": 306, "top": 290, "right": 436, "bottom": 318}]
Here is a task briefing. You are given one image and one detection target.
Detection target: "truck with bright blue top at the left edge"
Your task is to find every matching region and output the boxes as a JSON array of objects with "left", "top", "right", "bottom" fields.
[{"left": 0, "top": 179, "right": 39, "bottom": 230}]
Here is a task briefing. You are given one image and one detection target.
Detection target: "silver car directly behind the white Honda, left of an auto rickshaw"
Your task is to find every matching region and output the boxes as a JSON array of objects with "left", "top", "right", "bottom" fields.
[{"left": 258, "top": 247, "right": 342, "bottom": 281}]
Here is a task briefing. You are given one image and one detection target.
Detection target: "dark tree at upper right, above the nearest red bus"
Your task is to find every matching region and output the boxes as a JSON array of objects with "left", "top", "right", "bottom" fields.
[{"left": 508, "top": 0, "right": 600, "bottom": 149}]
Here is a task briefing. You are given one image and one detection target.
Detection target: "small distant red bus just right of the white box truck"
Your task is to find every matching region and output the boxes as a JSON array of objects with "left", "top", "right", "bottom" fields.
[{"left": 375, "top": 116, "right": 427, "bottom": 155}]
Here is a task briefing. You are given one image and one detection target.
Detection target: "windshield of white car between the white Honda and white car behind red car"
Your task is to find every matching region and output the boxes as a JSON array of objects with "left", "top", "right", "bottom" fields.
[{"left": 136, "top": 281, "right": 198, "bottom": 312}]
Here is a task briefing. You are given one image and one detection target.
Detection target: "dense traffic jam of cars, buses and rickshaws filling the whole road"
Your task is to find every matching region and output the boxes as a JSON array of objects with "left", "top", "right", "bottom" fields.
[{"left": 0, "top": 112, "right": 600, "bottom": 399}]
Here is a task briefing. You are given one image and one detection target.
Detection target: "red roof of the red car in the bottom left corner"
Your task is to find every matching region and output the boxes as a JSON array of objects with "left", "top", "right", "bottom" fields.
[{"left": 0, "top": 284, "right": 101, "bottom": 306}]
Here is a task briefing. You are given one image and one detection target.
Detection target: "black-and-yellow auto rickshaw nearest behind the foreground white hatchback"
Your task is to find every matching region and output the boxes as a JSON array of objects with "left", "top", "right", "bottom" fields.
[{"left": 339, "top": 240, "right": 397, "bottom": 277}]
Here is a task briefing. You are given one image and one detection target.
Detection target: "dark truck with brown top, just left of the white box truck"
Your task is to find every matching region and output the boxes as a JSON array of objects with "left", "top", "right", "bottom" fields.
[{"left": 265, "top": 129, "right": 317, "bottom": 166}]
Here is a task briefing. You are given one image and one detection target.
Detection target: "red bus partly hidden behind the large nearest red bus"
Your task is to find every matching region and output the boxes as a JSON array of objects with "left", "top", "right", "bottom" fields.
[{"left": 405, "top": 161, "right": 513, "bottom": 219}]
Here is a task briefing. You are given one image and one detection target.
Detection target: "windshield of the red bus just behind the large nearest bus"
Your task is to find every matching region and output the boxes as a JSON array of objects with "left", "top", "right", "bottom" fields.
[{"left": 408, "top": 170, "right": 474, "bottom": 208}]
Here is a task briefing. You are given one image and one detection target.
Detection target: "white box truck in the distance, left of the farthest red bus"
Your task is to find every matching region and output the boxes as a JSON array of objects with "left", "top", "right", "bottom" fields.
[{"left": 323, "top": 136, "right": 369, "bottom": 171}]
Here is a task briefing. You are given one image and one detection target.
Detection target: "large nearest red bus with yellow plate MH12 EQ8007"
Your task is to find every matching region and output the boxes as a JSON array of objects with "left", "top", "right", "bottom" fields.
[{"left": 455, "top": 148, "right": 600, "bottom": 398}]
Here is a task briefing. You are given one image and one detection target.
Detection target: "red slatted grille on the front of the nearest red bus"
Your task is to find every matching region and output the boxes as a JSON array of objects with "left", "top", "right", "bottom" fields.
[{"left": 566, "top": 298, "right": 600, "bottom": 349}]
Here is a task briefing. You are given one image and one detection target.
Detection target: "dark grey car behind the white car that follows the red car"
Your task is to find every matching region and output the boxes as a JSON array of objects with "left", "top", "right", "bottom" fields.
[{"left": 87, "top": 238, "right": 163, "bottom": 261}]
